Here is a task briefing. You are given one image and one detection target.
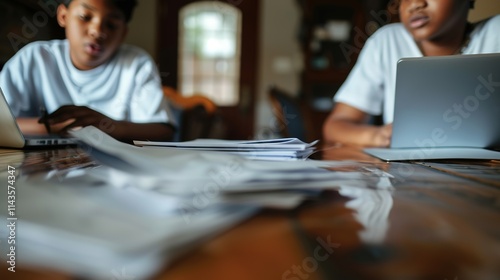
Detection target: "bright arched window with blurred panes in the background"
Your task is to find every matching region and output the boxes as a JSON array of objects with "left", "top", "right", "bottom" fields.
[{"left": 178, "top": 1, "right": 242, "bottom": 106}]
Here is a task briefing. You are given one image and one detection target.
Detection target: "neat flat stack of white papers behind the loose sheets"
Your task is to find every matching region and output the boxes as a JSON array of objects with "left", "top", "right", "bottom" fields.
[{"left": 134, "top": 138, "right": 318, "bottom": 160}]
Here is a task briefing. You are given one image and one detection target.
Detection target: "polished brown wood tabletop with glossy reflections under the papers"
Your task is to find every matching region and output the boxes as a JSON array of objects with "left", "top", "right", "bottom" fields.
[{"left": 0, "top": 146, "right": 500, "bottom": 280}]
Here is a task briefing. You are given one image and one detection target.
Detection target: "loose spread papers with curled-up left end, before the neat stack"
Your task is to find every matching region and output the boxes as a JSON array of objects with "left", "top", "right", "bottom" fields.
[{"left": 68, "top": 127, "right": 391, "bottom": 197}]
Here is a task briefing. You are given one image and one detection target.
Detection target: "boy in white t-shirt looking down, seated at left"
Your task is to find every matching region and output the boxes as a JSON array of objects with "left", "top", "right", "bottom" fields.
[{"left": 0, "top": 0, "right": 174, "bottom": 142}]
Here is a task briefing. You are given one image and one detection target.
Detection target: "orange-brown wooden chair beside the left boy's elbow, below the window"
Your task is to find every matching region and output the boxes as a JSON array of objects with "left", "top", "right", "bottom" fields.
[{"left": 163, "top": 86, "right": 221, "bottom": 141}]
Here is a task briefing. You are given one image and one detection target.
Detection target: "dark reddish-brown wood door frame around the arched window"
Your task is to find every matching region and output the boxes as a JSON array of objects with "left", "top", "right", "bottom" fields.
[{"left": 156, "top": 0, "right": 260, "bottom": 139}]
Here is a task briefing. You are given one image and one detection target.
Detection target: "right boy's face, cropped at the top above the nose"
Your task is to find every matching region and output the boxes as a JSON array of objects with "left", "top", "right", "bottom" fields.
[{"left": 399, "top": 0, "right": 470, "bottom": 42}]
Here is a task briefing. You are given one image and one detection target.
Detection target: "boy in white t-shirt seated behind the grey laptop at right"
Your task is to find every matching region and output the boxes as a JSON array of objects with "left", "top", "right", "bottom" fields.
[{"left": 323, "top": 0, "right": 500, "bottom": 147}]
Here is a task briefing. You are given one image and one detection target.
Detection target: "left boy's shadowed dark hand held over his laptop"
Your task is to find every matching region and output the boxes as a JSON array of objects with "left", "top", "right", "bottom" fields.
[{"left": 38, "top": 105, "right": 117, "bottom": 134}]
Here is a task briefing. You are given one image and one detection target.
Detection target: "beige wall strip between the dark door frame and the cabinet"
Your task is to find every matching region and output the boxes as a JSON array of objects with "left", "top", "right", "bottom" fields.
[{"left": 255, "top": 0, "right": 302, "bottom": 138}]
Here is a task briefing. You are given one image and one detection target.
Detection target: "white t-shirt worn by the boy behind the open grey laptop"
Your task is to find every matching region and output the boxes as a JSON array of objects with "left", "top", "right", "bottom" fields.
[{"left": 334, "top": 16, "right": 500, "bottom": 124}]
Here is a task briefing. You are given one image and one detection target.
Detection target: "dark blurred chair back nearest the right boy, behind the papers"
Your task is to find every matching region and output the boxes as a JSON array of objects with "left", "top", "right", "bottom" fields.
[{"left": 268, "top": 86, "right": 316, "bottom": 142}]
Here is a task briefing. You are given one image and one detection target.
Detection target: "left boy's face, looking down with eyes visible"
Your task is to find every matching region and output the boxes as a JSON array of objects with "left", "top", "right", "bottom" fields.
[{"left": 57, "top": 0, "right": 127, "bottom": 70}]
